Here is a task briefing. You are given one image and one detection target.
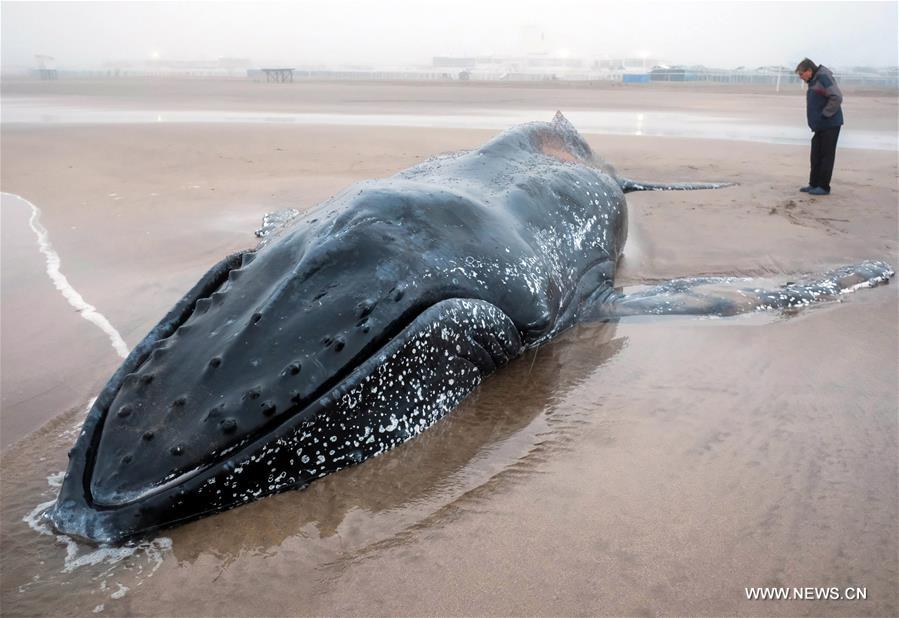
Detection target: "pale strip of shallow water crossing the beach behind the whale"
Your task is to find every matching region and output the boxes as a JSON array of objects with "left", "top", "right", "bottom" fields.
[{"left": 2, "top": 98, "right": 899, "bottom": 150}]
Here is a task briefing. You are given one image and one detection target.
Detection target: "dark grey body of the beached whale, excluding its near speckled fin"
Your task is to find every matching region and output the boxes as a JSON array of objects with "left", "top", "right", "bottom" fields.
[{"left": 49, "top": 115, "right": 888, "bottom": 543}]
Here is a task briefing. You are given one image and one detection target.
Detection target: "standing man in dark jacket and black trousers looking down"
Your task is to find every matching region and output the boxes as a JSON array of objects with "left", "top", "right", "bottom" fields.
[{"left": 796, "top": 58, "right": 843, "bottom": 195}]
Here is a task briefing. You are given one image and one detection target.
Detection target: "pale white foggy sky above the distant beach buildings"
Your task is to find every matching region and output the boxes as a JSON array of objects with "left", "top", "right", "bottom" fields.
[{"left": 0, "top": 0, "right": 899, "bottom": 68}]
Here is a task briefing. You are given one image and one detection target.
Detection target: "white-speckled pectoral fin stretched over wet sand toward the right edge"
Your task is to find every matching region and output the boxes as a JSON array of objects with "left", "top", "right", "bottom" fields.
[{"left": 581, "top": 261, "right": 894, "bottom": 320}]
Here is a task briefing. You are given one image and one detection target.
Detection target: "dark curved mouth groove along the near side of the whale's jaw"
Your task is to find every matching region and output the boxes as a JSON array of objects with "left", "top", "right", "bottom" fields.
[{"left": 85, "top": 295, "right": 486, "bottom": 510}]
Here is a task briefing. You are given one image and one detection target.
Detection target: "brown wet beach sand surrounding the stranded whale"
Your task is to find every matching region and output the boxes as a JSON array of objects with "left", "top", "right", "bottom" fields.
[{"left": 0, "top": 82, "right": 899, "bottom": 615}]
